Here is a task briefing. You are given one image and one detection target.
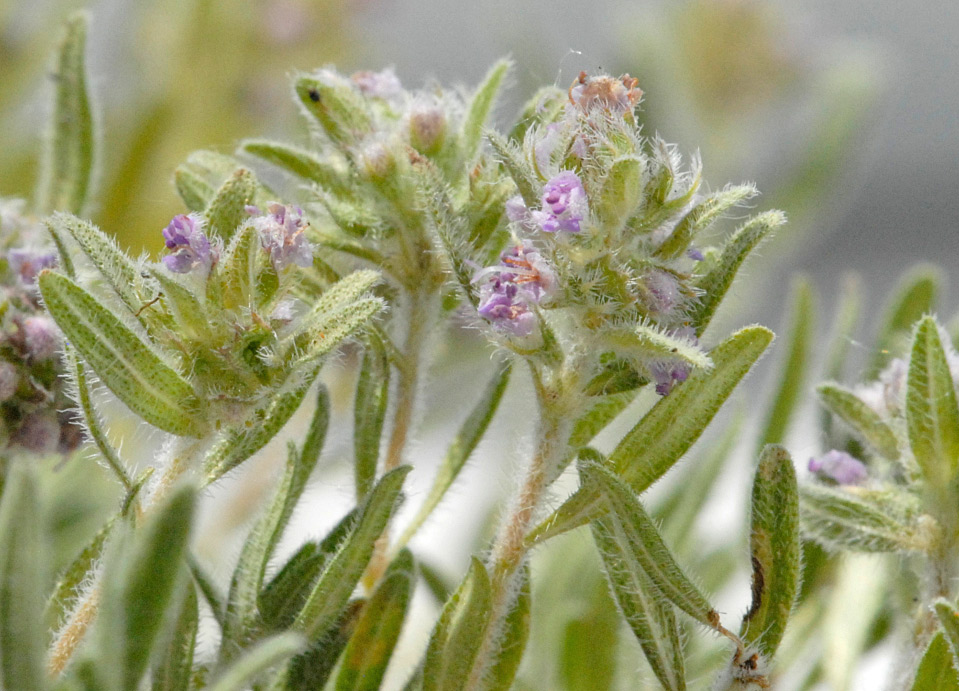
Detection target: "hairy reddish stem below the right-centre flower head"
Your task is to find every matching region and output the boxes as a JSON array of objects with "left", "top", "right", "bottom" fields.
[{"left": 465, "top": 373, "right": 572, "bottom": 691}]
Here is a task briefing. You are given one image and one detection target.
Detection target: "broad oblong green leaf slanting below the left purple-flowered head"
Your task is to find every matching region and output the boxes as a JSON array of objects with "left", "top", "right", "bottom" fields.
[{"left": 38, "top": 271, "right": 207, "bottom": 437}]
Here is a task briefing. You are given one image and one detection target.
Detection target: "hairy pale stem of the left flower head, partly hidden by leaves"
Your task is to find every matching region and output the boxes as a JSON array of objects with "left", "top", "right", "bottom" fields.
[{"left": 47, "top": 437, "right": 208, "bottom": 677}]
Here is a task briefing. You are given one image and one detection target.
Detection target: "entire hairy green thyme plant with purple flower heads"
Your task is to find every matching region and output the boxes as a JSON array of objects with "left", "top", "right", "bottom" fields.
[{"left": 0, "top": 9, "right": 959, "bottom": 691}]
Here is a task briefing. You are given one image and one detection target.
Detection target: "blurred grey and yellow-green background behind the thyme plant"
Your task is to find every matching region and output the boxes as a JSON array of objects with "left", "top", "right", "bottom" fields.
[{"left": 0, "top": 0, "right": 959, "bottom": 689}]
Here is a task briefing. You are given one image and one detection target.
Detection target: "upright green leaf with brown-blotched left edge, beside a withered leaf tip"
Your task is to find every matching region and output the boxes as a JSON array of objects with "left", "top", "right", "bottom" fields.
[{"left": 740, "top": 444, "right": 802, "bottom": 657}]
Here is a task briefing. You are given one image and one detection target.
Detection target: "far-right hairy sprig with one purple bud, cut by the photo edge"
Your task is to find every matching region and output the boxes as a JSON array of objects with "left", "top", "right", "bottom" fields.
[{"left": 801, "top": 270, "right": 959, "bottom": 689}]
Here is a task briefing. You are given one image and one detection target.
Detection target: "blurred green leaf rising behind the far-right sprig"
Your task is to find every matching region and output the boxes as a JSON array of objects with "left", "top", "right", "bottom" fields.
[{"left": 864, "top": 266, "right": 942, "bottom": 381}]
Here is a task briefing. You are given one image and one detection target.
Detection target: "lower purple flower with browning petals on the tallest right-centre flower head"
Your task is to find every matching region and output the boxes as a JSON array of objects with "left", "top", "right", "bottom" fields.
[{"left": 473, "top": 240, "right": 557, "bottom": 336}]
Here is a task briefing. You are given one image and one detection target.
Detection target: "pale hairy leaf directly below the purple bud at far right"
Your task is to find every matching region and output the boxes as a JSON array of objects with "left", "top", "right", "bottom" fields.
[{"left": 800, "top": 485, "right": 929, "bottom": 552}]
